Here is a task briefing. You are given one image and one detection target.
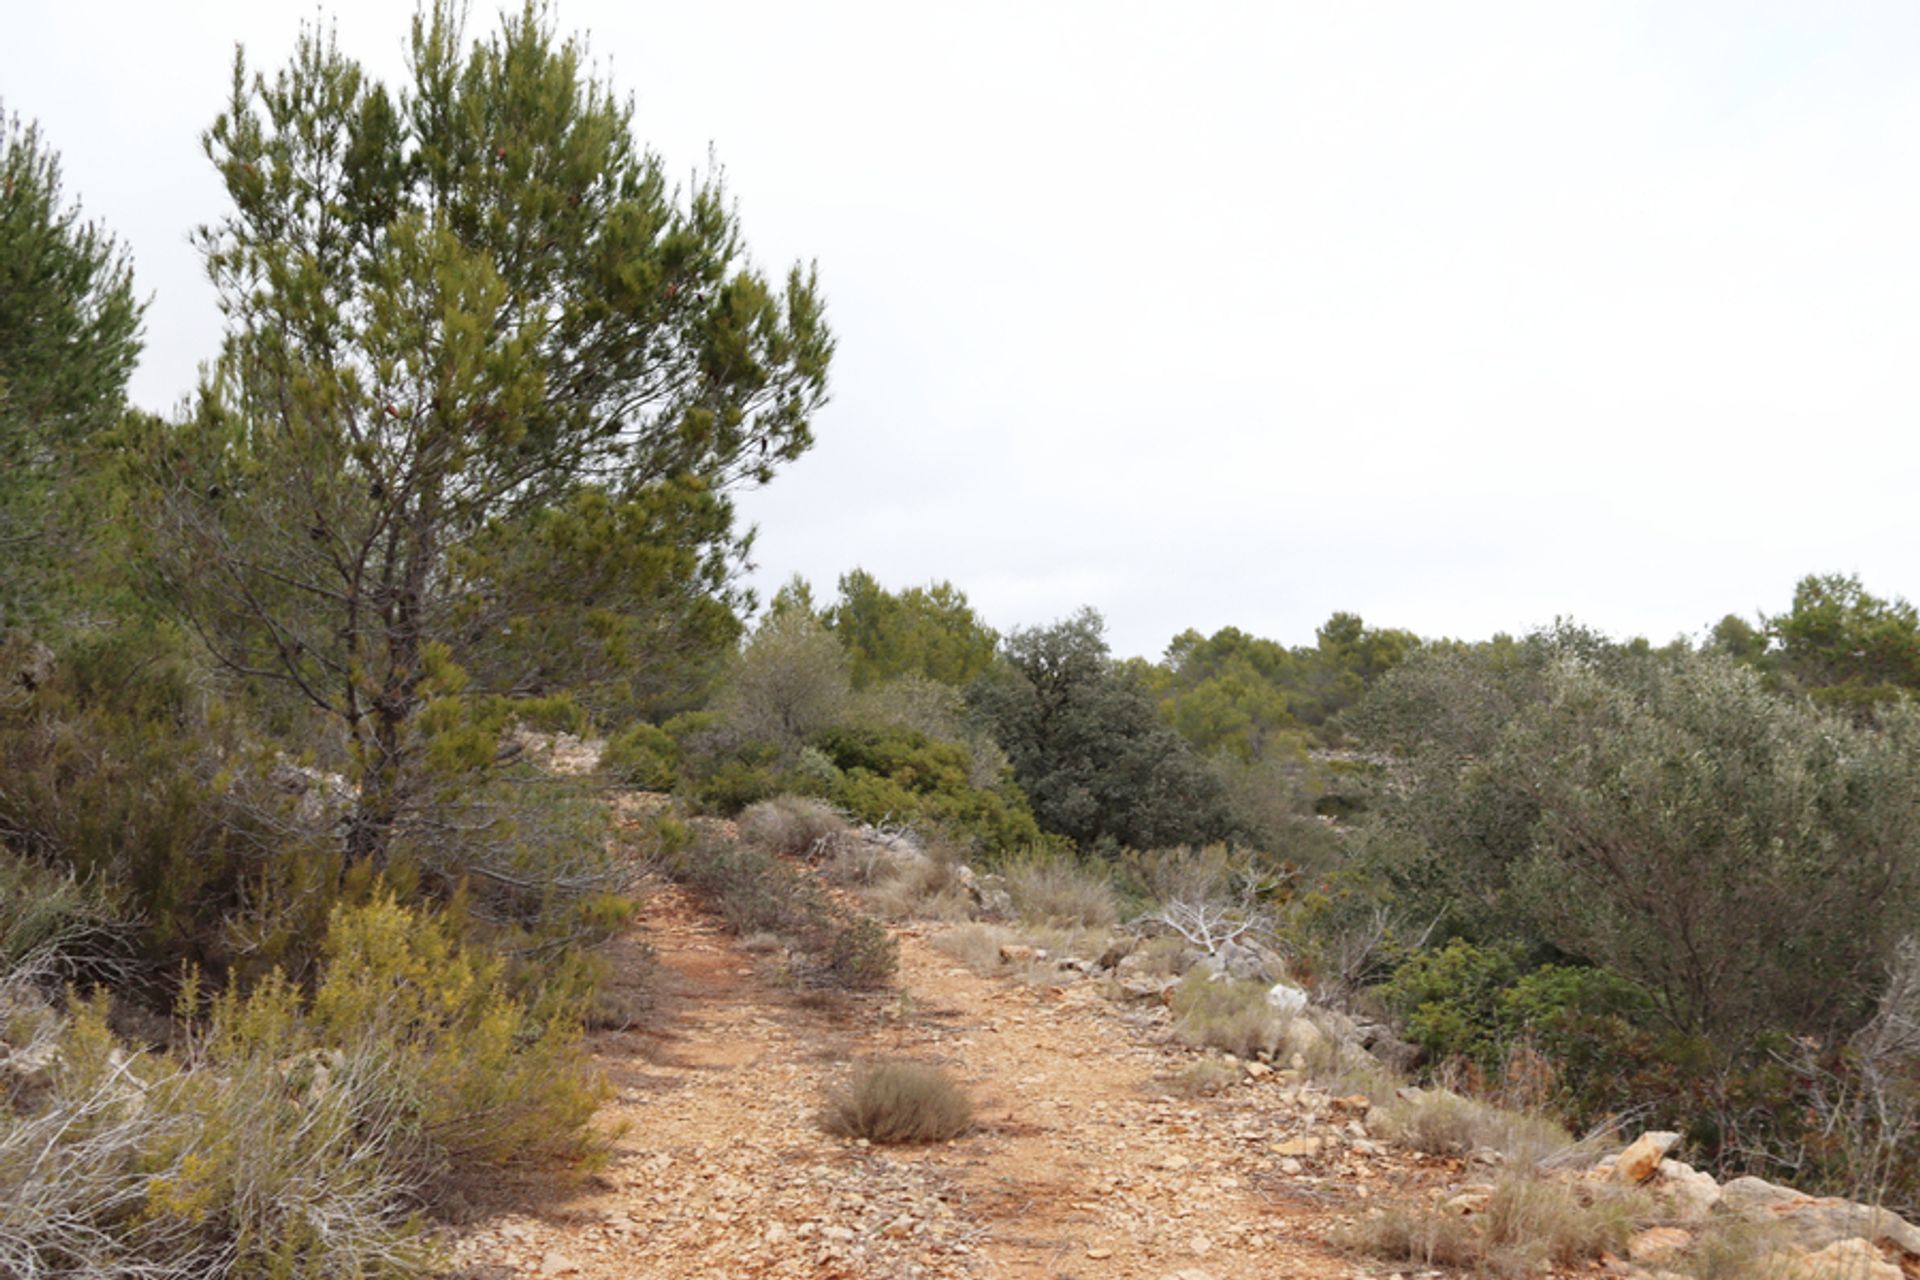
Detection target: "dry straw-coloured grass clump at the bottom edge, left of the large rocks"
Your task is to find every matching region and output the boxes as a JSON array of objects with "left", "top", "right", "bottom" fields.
[{"left": 1344, "top": 1173, "right": 1651, "bottom": 1278}]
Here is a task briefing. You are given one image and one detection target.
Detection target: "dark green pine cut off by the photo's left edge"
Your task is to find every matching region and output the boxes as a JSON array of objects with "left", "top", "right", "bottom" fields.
[{"left": 0, "top": 111, "right": 144, "bottom": 631}]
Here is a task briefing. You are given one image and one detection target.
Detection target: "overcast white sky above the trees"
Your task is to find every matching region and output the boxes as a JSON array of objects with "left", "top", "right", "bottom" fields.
[{"left": 0, "top": 0, "right": 1920, "bottom": 654}]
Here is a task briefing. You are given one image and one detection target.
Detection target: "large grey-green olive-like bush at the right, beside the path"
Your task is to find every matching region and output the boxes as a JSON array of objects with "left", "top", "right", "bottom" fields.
[{"left": 1356, "top": 629, "right": 1920, "bottom": 1036}]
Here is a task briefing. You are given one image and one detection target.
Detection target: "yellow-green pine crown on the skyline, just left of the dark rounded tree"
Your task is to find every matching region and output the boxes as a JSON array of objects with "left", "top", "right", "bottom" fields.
[{"left": 826, "top": 568, "right": 998, "bottom": 689}]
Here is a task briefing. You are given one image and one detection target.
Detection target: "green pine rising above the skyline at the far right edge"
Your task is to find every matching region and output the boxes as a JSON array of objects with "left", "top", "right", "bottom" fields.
[{"left": 1766, "top": 574, "right": 1920, "bottom": 716}]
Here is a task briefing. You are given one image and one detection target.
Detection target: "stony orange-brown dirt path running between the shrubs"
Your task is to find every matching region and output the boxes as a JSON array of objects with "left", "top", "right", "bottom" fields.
[{"left": 453, "top": 889, "right": 1377, "bottom": 1280}]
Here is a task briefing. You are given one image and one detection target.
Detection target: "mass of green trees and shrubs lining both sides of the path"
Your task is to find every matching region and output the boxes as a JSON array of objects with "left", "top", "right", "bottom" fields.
[{"left": 11, "top": 6, "right": 1920, "bottom": 1276}]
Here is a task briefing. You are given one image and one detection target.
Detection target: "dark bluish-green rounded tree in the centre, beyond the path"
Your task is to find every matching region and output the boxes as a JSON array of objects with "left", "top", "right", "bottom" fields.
[{"left": 970, "top": 608, "right": 1233, "bottom": 848}]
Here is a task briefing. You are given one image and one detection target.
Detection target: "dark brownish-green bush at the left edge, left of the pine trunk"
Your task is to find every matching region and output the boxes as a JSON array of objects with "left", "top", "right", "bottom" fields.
[{"left": 0, "top": 629, "right": 342, "bottom": 977}]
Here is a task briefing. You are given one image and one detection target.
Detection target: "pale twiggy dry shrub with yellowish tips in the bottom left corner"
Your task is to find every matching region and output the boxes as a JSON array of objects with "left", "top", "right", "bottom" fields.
[{"left": 0, "top": 998, "right": 434, "bottom": 1280}]
